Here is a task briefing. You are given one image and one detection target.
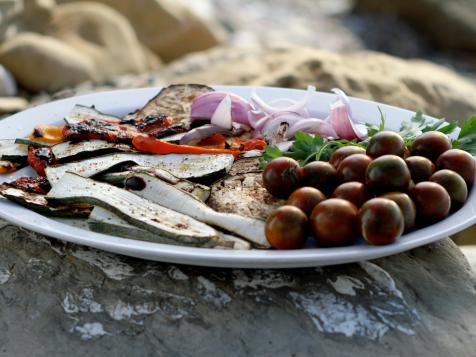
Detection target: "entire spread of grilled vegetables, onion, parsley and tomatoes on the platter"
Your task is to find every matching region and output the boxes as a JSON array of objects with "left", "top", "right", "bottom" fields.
[{"left": 0, "top": 84, "right": 476, "bottom": 250}]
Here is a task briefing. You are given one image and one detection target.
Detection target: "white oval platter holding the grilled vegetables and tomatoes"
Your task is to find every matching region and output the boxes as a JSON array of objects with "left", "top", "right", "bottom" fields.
[{"left": 0, "top": 86, "right": 476, "bottom": 268}]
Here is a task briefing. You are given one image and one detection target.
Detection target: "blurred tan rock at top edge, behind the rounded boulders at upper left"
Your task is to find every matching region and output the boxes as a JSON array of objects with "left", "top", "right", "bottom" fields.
[{"left": 57, "top": 0, "right": 224, "bottom": 61}]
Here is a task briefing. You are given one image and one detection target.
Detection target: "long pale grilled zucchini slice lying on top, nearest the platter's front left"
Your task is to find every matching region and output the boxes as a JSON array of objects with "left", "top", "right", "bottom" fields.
[{"left": 46, "top": 172, "right": 218, "bottom": 246}]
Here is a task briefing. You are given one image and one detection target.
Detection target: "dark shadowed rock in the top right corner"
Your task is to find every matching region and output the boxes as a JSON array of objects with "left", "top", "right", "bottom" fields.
[{"left": 356, "top": 0, "right": 476, "bottom": 51}]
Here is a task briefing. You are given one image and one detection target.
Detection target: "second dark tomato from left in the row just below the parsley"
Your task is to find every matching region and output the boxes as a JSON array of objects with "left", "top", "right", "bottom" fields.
[{"left": 302, "top": 161, "right": 337, "bottom": 194}]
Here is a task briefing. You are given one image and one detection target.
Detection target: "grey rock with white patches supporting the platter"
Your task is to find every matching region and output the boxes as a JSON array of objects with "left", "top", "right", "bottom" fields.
[{"left": 0, "top": 221, "right": 476, "bottom": 356}]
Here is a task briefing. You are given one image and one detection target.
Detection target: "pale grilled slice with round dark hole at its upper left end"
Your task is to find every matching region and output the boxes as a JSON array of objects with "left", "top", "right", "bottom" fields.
[{"left": 126, "top": 173, "right": 270, "bottom": 248}]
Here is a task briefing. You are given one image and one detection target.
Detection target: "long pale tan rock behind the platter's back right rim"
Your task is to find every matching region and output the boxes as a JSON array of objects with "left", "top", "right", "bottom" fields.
[{"left": 160, "top": 48, "right": 476, "bottom": 122}]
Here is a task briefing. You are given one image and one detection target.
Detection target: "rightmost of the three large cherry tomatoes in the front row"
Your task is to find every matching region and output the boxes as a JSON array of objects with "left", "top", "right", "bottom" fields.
[{"left": 359, "top": 197, "right": 405, "bottom": 245}]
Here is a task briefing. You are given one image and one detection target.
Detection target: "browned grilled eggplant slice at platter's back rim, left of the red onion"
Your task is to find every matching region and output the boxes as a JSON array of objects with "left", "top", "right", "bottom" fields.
[{"left": 134, "top": 84, "right": 214, "bottom": 135}]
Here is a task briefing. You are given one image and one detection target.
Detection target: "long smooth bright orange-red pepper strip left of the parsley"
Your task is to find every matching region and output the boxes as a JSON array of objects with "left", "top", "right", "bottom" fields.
[{"left": 132, "top": 135, "right": 239, "bottom": 157}]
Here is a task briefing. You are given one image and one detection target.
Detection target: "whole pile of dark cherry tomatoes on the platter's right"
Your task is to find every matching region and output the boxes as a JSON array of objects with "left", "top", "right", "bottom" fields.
[{"left": 263, "top": 131, "right": 476, "bottom": 249}]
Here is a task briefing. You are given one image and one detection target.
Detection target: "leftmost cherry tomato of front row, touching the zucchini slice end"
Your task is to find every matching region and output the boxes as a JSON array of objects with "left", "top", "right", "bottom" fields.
[{"left": 265, "top": 206, "right": 307, "bottom": 249}]
